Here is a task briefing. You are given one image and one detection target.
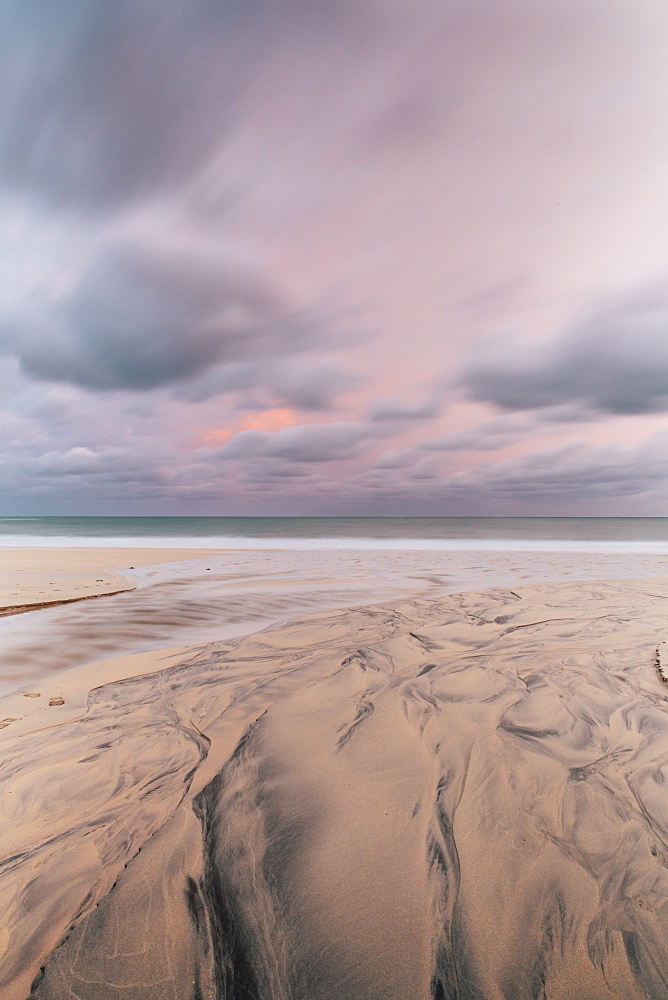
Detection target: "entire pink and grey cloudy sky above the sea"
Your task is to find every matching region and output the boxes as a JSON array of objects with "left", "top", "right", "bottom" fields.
[{"left": 0, "top": 0, "right": 668, "bottom": 516}]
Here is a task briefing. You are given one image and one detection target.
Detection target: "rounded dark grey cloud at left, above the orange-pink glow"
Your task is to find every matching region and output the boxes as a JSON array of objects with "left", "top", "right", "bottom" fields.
[{"left": 8, "top": 247, "right": 316, "bottom": 390}]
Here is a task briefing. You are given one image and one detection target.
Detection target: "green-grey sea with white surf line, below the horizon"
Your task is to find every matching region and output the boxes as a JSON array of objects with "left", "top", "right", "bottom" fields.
[{"left": 0, "top": 517, "right": 668, "bottom": 553}]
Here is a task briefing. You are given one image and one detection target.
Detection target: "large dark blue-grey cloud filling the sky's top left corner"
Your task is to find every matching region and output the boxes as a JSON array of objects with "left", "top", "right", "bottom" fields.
[{"left": 0, "top": 0, "right": 366, "bottom": 209}]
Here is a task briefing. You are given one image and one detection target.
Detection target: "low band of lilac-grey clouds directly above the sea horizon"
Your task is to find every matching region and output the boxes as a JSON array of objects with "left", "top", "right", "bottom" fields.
[{"left": 5, "top": 412, "right": 668, "bottom": 515}]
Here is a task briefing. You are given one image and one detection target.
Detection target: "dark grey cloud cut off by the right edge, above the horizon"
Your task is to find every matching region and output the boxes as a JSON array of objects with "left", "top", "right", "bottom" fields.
[{"left": 461, "top": 293, "right": 668, "bottom": 419}]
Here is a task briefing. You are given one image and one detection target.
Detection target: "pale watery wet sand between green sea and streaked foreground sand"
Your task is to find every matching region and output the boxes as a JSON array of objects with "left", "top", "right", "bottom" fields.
[{"left": 0, "top": 548, "right": 668, "bottom": 696}]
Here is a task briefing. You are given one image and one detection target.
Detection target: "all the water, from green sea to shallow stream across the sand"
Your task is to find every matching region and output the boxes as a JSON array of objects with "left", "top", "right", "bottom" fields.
[{"left": 0, "top": 517, "right": 668, "bottom": 693}]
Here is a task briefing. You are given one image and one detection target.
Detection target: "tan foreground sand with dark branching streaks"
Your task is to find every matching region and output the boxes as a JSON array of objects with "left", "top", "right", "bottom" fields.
[{"left": 0, "top": 580, "right": 668, "bottom": 1000}]
